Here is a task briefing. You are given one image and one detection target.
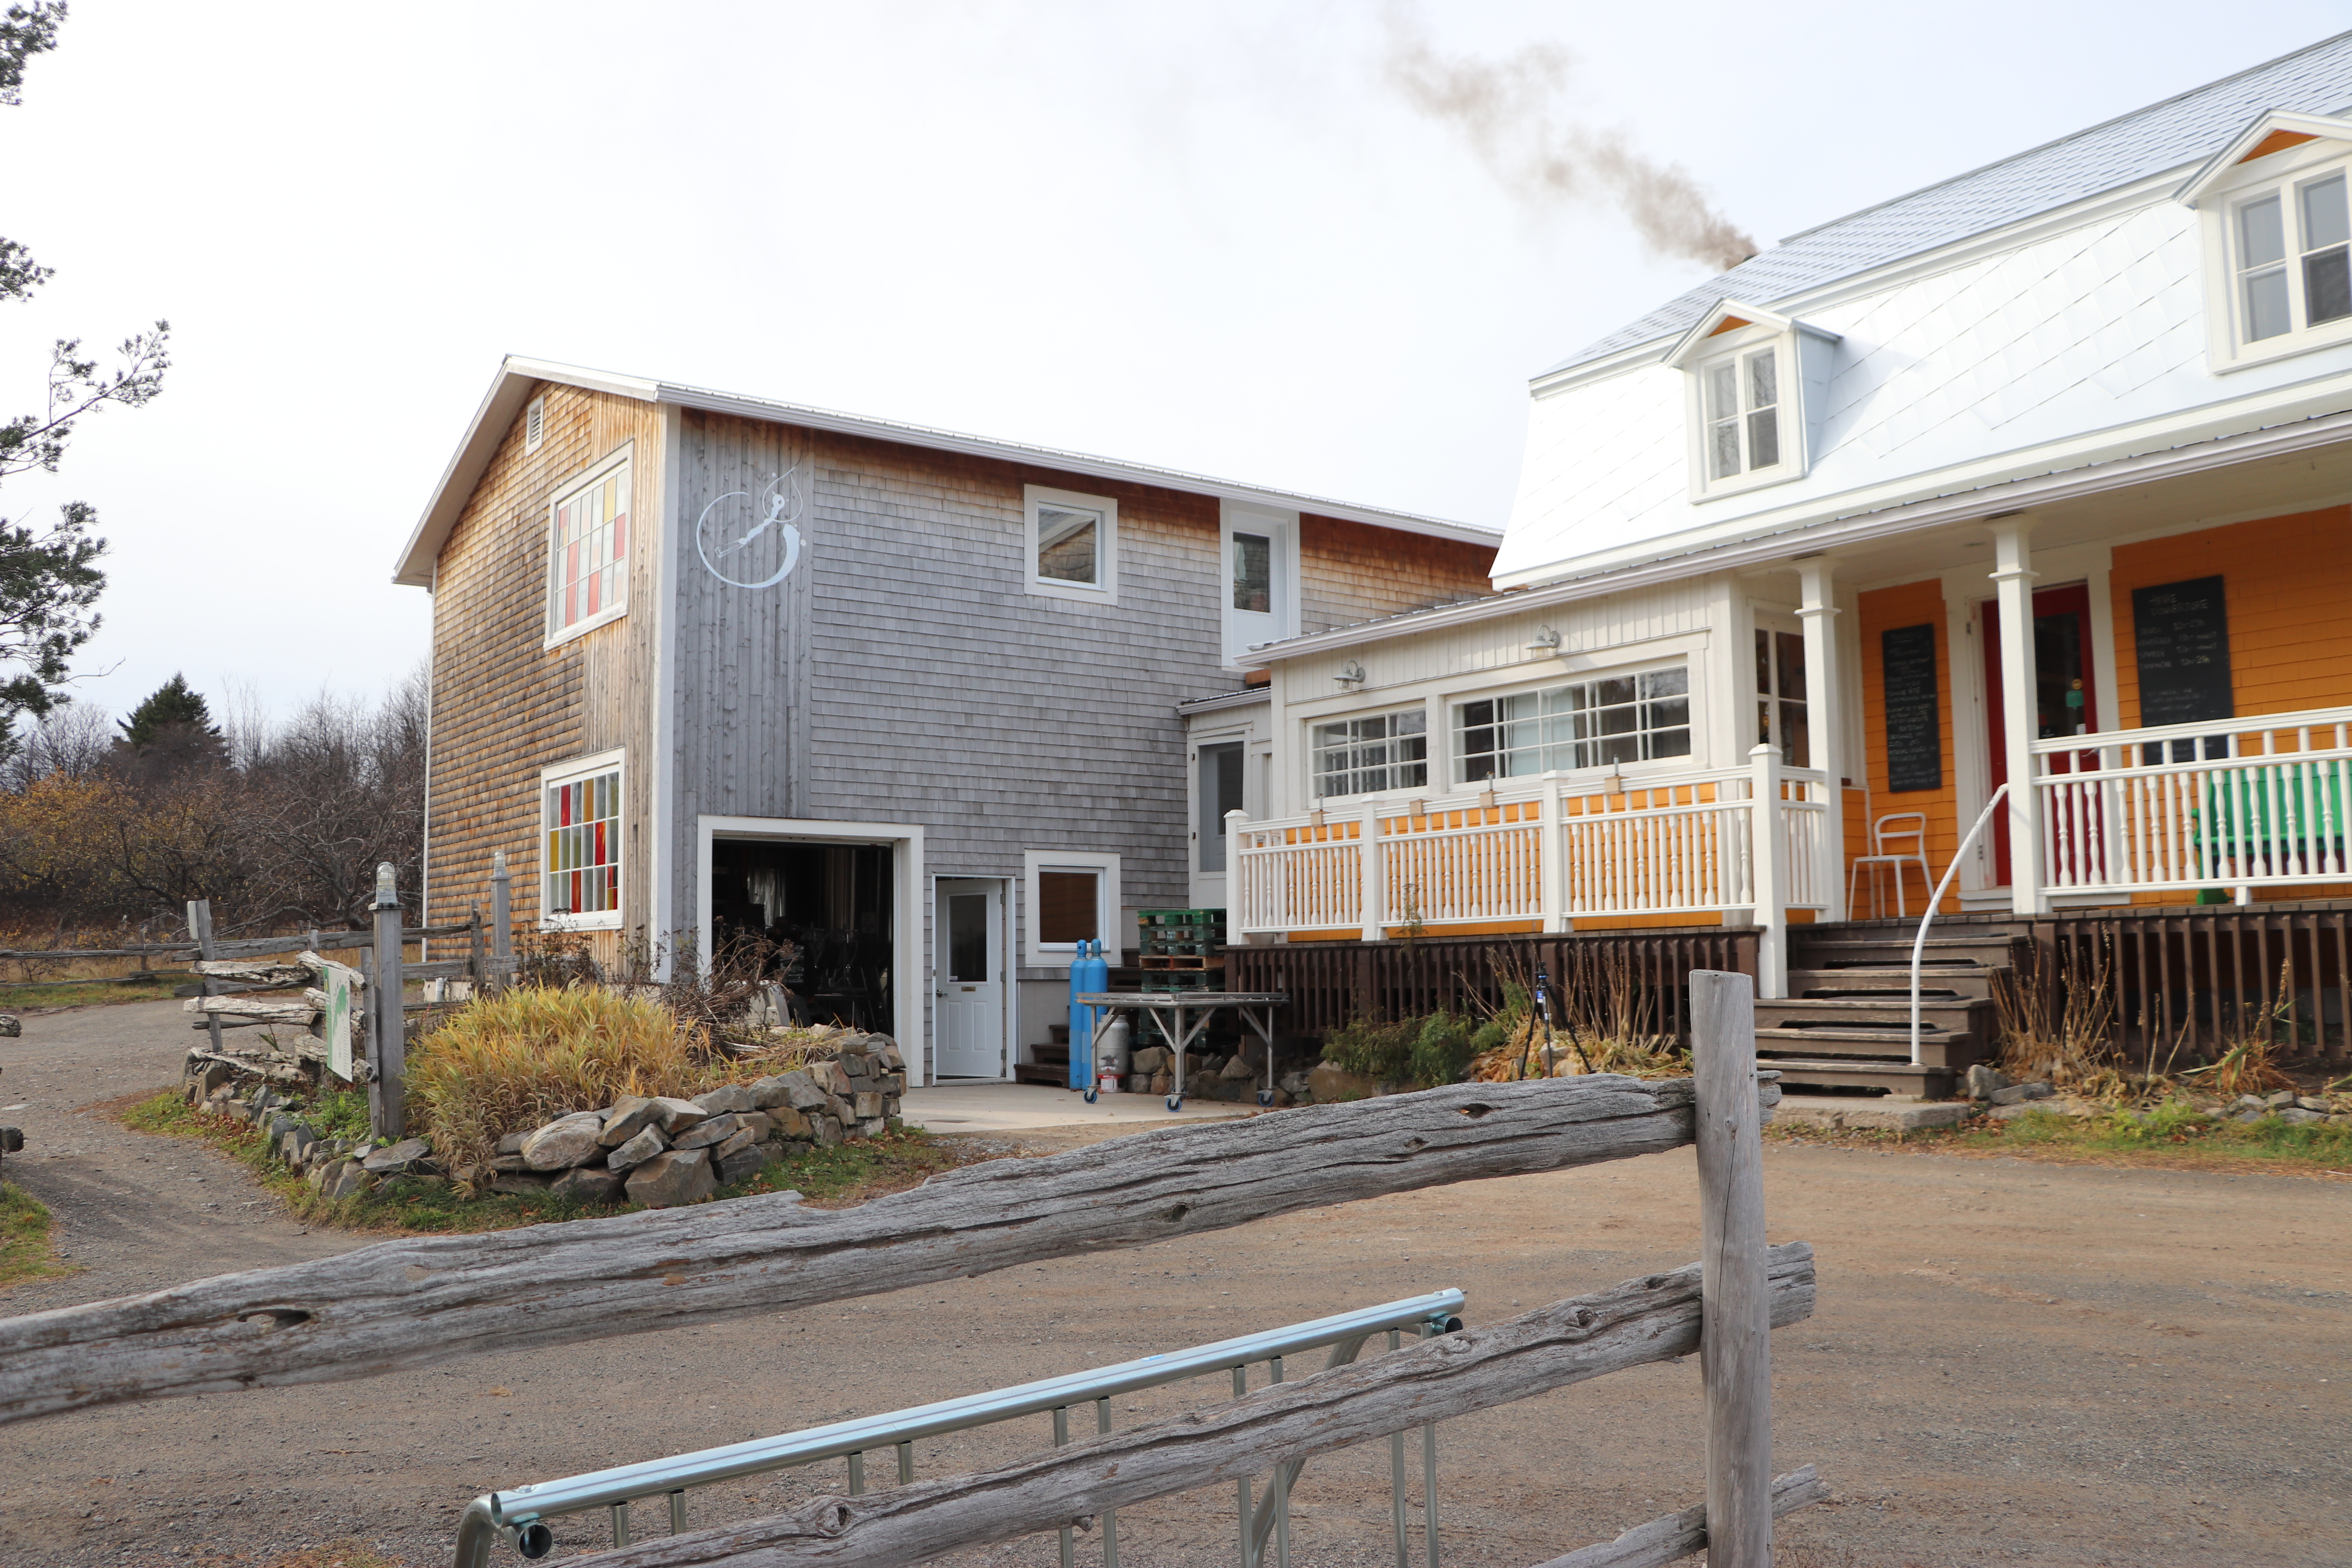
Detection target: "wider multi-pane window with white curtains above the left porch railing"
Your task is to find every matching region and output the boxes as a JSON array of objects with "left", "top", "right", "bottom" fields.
[{"left": 1454, "top": 665, "right": 1691, "bottom": 783}]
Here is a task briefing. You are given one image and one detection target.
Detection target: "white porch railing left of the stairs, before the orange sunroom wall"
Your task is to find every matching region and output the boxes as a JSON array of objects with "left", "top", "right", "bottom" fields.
[{"left": 1228, "top": 748, "right": 1837, "bottom": 964}]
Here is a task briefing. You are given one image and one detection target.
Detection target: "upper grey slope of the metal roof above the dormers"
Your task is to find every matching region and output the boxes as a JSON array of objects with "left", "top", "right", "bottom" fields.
[{"left": 1538, "top": 33, "right": 2352, "bottom": 381}]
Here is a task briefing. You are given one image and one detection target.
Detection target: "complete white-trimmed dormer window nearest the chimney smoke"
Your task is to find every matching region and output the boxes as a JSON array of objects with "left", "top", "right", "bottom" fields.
[{"left": 1665, "top": 299, "right": 1837, "bottom": 501}]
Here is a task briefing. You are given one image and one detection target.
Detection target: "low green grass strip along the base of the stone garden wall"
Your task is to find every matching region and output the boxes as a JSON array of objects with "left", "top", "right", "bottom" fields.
[{"left": 122, "top": 1091, "right": 997, "bottom": 1232}]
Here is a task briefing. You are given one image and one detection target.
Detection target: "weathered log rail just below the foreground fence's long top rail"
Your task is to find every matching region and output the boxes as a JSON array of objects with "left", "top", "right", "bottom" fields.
[{"left": 506, "top": 1241, "right": 1813, "bottom": 1568}]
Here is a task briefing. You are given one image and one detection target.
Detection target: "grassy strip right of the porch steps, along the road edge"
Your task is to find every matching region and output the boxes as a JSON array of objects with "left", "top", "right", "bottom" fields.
[{"left": 1764, "top": 1100, "right": 2352, "bottom": 1176}]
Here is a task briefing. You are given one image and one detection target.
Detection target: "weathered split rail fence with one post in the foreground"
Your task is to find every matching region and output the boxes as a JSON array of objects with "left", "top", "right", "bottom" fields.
[{"left": 0, "top": 971, "right": 1825, "bottom": 1568}]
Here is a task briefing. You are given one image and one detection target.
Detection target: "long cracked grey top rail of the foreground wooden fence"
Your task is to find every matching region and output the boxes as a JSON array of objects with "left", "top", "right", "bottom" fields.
[{"left": 0, "top": 1074, "right": 1780, "bottom": 1422}]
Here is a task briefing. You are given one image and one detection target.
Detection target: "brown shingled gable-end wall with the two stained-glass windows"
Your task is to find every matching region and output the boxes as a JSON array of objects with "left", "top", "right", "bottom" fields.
[{"left": 426, "top": 386, "right": 661, "bottom": 952}]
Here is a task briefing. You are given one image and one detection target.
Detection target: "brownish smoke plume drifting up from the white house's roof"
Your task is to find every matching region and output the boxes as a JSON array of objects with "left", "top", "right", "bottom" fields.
[{"left": 1385, "top": 7, "right": 1757, "bottom": 270}]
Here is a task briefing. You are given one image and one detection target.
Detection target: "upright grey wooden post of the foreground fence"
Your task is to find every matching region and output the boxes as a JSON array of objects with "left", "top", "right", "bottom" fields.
[{"left": 1691, "top": 969, "right": 1771, "bottom": 1568}]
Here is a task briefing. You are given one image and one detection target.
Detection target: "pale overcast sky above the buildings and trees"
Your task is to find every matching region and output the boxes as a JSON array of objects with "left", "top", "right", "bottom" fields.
[{"left": 0, "top": 0, "right": 2345, "bottom": 712}]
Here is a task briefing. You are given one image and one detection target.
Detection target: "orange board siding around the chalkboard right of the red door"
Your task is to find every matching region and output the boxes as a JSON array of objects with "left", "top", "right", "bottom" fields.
[{"left": 2107, "top": 505, "right": 2352, "bottom": 905}]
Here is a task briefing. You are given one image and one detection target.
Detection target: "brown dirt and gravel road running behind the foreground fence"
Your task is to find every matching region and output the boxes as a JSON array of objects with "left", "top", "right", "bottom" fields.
[{"left": 0, "top": 1006, "right": 2352, "bottom": 1568}]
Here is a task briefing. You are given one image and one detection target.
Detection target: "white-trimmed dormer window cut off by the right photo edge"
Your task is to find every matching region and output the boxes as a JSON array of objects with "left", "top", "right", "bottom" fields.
[{"left": 2180, "top": 113, "right": 2352, "bottom": 372}]
